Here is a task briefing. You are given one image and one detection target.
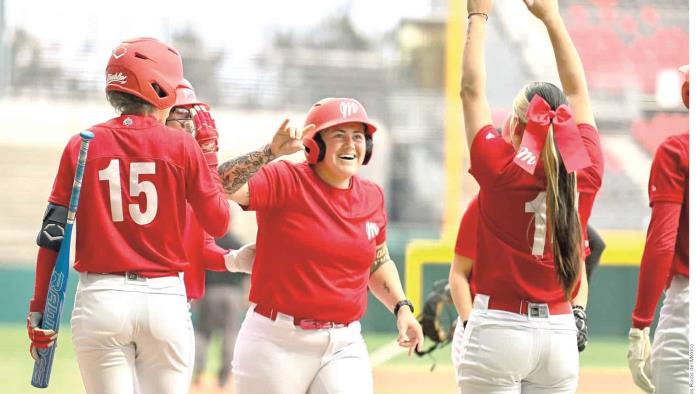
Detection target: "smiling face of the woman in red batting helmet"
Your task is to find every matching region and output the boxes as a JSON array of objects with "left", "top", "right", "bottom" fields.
[{"left": 316, "top": 122, "right": 366, "bottom": 187}]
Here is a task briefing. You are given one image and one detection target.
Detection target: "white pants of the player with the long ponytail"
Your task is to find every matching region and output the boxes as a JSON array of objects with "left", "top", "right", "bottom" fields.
[{"left": 452, "top": 294, "right": 580, "bottom": 394}]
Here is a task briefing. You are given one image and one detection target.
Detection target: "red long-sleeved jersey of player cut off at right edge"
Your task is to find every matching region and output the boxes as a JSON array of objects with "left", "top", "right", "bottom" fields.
[{"left": 633, "top": 133, "right": 689, "bottom": 328}]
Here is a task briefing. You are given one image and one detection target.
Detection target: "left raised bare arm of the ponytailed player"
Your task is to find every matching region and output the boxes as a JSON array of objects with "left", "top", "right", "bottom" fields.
[{"left": 460, "top": 0, "right": 493, "bottom": 148}]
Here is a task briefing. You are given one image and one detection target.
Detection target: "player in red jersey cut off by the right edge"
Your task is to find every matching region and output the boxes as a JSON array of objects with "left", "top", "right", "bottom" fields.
[{"left": 628, "top": 66, "right": 689, "bottom": 394}]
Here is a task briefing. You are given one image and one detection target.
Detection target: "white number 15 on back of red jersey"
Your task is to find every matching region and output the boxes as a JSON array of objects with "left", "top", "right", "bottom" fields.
[{"left": 99, "top": 159, "right": 157, "bottom": 226}]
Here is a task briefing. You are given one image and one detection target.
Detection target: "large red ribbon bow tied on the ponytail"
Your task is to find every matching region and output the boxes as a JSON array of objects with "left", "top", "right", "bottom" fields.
[{"left": 514, "top": 94, "right": 592, "bottom": 174}]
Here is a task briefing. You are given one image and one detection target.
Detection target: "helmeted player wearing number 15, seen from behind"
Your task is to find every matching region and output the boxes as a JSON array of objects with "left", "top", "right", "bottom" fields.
[{"left": 29, "top": 38, "right": 229, "bottom": 393}]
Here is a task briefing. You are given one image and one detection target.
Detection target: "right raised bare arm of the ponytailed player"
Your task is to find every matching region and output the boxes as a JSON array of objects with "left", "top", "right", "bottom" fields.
[{"left": 524, "top": 0, "right": 597, "bottom": 127}]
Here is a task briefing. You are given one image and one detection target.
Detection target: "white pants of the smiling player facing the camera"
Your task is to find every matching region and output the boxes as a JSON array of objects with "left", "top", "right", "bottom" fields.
[{"left": 232, "top": 305, "right": 372, "bottom": 394}]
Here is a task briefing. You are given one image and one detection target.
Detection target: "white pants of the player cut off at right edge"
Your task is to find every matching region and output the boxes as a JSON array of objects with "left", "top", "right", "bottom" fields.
[{"left": 650, "top": 275, "right": 689, "bottom": 394}]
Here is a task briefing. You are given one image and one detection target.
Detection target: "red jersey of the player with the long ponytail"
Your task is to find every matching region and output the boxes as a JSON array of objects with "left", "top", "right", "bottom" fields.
[{"left": 467, "top": 124, "right": 604, "bottom": 303}]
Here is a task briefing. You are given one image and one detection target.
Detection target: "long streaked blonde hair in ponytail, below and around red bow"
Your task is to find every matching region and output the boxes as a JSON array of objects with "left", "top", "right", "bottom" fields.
[{"left": 513, "top": 82, "right": 582, "bottom": 300}]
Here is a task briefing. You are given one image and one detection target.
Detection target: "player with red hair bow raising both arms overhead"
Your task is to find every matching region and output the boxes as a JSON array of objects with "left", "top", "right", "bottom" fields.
[{"left": 452, "top": 0, "right": 603, "bottom": 394}]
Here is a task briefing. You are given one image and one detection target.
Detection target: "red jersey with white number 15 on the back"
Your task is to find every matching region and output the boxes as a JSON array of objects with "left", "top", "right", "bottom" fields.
[{"left": 49, "top": 115, "right": 230, "bottom": 277}]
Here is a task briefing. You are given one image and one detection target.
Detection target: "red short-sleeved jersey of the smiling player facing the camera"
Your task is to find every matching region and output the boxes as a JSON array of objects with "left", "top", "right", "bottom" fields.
[{"left": 246, "top": 161, "right": 387, "bottom": 323}]
